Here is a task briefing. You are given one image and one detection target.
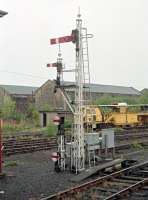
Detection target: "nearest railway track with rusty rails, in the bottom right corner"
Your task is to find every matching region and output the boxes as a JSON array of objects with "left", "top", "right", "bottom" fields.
[{"left": 41, "top": 161, "right": 148, "bottom": 200}]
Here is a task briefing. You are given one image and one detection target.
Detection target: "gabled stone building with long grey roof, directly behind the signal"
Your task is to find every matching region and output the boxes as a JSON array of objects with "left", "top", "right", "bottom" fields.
[{"left": 35, "top": 80, "right": 141, "bottom": 126}]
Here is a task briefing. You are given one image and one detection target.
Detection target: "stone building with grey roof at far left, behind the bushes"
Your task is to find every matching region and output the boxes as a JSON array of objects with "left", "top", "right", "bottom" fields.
[{"left": 0, "top": 85, "right": 37, "bottom": 114}]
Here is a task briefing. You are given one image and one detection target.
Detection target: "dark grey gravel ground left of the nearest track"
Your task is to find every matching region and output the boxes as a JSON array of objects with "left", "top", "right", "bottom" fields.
[{"left": 0, "top": 150, "right": 148, "bottom": 200}]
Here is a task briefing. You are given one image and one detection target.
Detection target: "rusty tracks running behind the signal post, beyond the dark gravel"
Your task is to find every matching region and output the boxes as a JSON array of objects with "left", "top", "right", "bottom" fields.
[{"left": 3, "top": 133, "right": 148, "bottom": 156}]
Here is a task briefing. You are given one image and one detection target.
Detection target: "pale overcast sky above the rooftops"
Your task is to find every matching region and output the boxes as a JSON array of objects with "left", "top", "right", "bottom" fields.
[{"left": 0, "top": 0, "right": 148, "bottom": 89}]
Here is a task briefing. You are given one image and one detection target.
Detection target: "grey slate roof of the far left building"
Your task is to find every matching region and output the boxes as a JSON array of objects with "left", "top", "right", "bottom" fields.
[{"left": 0, "top": 85, "right": 37, "bottom": 95}]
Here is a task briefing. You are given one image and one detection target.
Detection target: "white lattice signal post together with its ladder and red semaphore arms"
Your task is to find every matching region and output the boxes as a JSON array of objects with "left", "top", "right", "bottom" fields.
[{"left": 47, "top": 14, "right": 90, "bottom": 173}]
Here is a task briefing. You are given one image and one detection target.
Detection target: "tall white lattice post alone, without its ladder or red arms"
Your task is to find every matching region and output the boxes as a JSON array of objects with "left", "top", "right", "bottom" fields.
[{"left": 71, "top": 14, "right": 85, "bottom": 173}]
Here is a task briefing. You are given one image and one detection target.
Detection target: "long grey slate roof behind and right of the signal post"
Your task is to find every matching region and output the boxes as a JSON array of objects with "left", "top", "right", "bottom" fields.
[{"left": 64, "top": 82, "right": 141, "bottom": 95}]
